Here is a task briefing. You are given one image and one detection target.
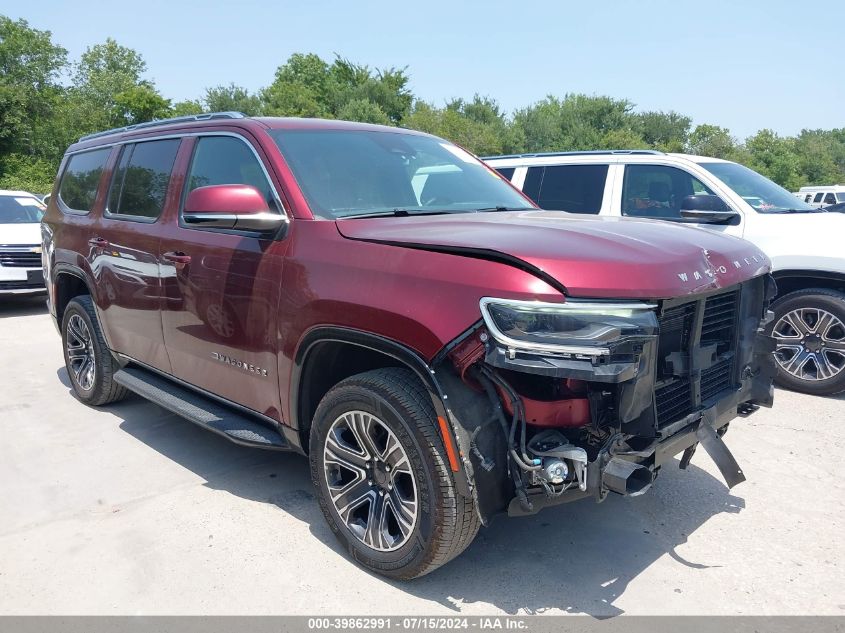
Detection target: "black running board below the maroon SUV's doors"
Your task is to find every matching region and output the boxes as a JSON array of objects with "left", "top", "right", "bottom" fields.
[{"left": 114, "top": 366, "right": 291, "bottom": 451}]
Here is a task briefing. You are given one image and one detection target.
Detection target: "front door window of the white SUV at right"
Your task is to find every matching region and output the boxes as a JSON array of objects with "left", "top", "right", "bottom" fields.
[{"left": 622, "top": 165, "right": 713, "bottom": 218}]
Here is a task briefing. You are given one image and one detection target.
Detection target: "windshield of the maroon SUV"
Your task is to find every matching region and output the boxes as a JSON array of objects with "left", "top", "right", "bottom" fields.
[{"left": 270, "top": 130, "right": 534, "bottom": 218}]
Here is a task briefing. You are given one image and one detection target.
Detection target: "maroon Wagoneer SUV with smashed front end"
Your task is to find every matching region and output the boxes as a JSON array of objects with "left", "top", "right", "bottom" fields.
[{"left": 42, "top": 113, "right": 774, "bottom": 578}]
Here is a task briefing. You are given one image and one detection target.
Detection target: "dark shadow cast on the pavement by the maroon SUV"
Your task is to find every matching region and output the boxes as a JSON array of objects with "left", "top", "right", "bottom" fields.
[{"left": 57, "top": 368, "right": 745, "bottom": 618}]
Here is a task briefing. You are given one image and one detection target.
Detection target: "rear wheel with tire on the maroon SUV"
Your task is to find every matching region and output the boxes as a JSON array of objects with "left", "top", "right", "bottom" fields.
[{"left": 62, "top": 295, "right": 126, "bottom": 405}]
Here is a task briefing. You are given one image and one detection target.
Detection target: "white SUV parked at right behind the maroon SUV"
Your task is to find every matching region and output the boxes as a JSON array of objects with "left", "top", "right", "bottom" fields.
[{"left": 485, "top": 150, "right": 845, "bottom": 395}]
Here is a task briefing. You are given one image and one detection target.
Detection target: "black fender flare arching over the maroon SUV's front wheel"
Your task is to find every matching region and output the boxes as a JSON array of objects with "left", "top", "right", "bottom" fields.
[{"left": 289, "top": 326, "right": 475, "bottom": 499}]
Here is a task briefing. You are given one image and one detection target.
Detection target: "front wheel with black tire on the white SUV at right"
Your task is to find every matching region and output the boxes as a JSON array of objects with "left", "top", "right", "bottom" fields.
[{"left": 769, "top": 288, "right": 845, "bottom": 396}]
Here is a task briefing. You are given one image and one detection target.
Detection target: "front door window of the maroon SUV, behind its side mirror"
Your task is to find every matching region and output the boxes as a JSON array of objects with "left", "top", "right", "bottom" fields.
[{"left": 186, "top": 136, "right": 277, "bottom": 209}]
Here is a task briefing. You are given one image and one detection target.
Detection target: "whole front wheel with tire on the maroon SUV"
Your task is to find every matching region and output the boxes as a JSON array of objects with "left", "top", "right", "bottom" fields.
[{"left": 310, "top": 368, "right": 480, "bottom": 579}]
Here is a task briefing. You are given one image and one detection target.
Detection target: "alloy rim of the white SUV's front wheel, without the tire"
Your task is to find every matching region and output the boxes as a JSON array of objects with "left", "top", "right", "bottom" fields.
[{"left": 772, "top": 308, "right": 845, "bottom": 381}]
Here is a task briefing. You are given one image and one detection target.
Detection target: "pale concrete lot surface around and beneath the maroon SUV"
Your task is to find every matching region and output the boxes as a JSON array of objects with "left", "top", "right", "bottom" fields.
[{"left": 0, "top": 298, "right": 845, "bottom": 615}]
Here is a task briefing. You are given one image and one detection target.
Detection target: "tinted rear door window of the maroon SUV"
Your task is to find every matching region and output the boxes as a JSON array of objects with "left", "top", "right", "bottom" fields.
[{"left": 108, "top": 139, "right": 181, "bottom": 220}]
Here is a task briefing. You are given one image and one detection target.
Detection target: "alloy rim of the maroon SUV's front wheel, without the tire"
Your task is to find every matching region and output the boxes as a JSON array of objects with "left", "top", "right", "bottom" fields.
[{"left": 323, "top": 411, "right": 419, "bottom": 551}]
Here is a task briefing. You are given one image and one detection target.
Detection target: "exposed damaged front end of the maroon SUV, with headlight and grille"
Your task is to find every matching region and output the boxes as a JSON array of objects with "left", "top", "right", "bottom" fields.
[{"left": 433, "top": 275, "right": 775, "bottom": 521}]
